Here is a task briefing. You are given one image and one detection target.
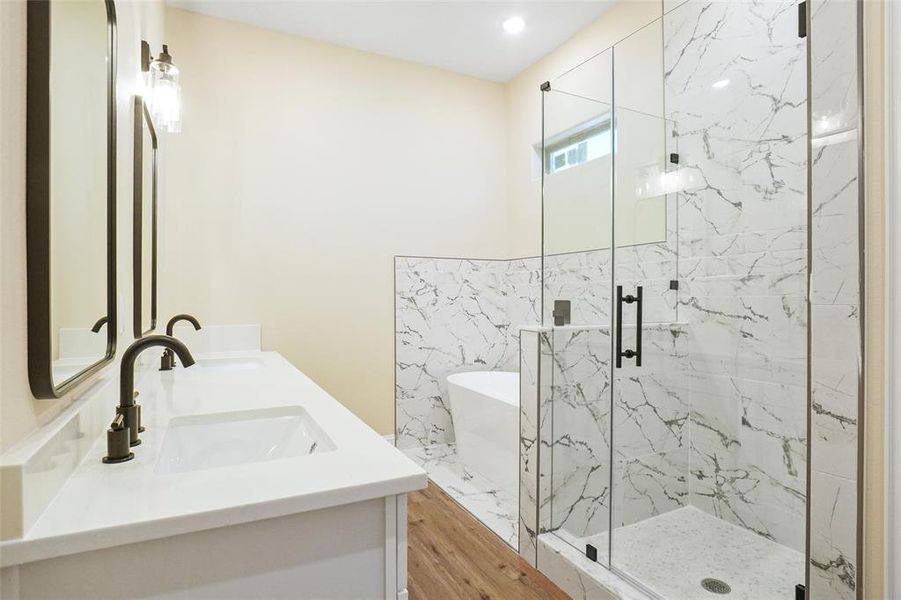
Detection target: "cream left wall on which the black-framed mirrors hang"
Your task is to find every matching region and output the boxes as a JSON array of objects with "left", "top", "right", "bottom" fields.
[{"left": 0, "top": 0, "right": 163, "bottom": 450}]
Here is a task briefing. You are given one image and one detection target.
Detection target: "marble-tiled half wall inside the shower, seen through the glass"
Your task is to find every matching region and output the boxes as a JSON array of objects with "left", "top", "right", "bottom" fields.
[{"left": 546, "top": 323, "right": 690, "bottom": 548}]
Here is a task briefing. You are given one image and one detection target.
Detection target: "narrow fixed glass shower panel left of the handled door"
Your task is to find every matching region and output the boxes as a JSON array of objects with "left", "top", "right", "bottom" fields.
[{"left": 542, "top": 51, "right": 614, "bottom": 564}]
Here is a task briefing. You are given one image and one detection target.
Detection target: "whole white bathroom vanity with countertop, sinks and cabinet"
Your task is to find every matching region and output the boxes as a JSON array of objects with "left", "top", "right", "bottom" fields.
[{"left": 0, "top": 351, "right": 426, "bottom": 599}]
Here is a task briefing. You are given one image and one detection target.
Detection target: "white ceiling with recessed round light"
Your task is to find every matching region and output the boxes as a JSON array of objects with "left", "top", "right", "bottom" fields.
[{"left": 167, "top": 0, "right": 615, "bottom": 82}]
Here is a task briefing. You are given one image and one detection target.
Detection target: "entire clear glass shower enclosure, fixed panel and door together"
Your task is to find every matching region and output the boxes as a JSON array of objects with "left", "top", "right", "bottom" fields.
[{"left": 539, "top": 1, "right": 808, "bottom": 599}]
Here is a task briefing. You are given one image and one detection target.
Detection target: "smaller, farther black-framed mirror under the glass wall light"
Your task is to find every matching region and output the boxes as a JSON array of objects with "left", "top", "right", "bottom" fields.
[{"left": 132, "top": 96, "right": 159, "bottom": 338}]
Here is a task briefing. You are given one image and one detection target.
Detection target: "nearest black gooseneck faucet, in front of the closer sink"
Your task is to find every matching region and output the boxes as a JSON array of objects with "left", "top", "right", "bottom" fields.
[{"left": 103, "top": 335, "right": 194, "bottom": 463}]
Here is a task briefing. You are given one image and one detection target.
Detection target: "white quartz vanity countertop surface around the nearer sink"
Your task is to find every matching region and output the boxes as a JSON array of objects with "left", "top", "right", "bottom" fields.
[{"left": 0, "top": 352, "right": 427, "bottom": 567}]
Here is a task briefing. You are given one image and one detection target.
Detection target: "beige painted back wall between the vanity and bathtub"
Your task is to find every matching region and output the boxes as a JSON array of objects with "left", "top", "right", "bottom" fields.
[{"left": 160, "top": 9, "right": 507, "bottom": 433}]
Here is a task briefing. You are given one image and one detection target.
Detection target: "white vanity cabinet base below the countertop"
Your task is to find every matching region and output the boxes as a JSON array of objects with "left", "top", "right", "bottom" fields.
[{"left": 0, "top": 495, "right": 406, "bottom": 600}]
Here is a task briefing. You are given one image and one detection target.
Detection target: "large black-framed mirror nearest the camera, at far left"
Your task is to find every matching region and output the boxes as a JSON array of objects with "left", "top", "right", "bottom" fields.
[{"left": 26, "top": 0, "right": 117, "bottom": 398}]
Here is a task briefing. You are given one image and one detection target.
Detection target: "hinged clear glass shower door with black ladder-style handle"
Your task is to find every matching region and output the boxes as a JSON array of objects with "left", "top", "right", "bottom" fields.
[{"left": 610, "top": 0, "right": 807, "bottom": 600}]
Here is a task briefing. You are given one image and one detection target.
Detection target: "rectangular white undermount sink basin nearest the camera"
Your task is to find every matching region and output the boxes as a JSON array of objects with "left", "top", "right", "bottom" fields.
[{"left": 156, "top": 406, "right": 335, "bottom": 473}]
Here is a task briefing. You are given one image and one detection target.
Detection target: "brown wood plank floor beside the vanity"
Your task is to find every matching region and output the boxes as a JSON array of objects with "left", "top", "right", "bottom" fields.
[{"left": 407, "top": 481, "right": 569, "bottom": 600}]
